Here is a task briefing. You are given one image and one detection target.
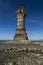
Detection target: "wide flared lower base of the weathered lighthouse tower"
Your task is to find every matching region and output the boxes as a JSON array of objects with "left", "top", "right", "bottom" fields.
[{"left": 13, "top": 29, "right": 28, "bottom": 41}]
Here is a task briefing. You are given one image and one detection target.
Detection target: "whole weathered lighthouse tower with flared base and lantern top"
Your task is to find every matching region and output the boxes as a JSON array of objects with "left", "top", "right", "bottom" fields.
[{"left": 14, "top": 4, "right": 28, "bottom": 40}]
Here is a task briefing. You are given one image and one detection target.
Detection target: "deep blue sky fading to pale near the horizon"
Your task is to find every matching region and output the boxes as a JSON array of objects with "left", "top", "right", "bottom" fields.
[{"left": 0, "top": 0, "right": 43, "bottom": 40}]
